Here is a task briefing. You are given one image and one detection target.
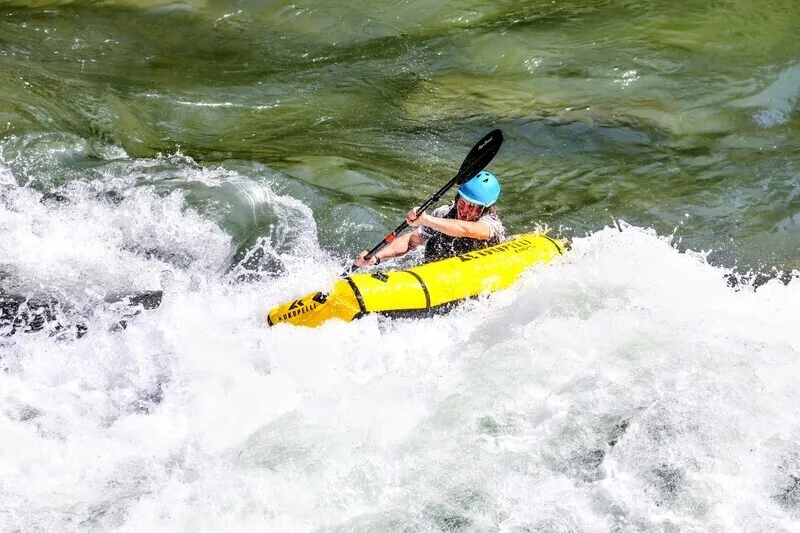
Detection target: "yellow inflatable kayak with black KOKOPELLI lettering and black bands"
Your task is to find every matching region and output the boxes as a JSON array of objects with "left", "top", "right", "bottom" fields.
[{"left": 267, "top": 233, "right": 566, "bottom": 327}]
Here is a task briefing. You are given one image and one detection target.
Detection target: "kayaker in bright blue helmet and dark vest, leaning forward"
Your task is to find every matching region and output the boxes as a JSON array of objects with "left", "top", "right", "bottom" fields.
[{"left": 355, "top": 170, "right": 506, "bottom": 267}]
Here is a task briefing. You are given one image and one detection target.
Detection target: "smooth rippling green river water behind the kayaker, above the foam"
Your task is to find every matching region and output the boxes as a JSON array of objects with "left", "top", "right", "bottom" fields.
[{"left": 0, "top": 0, "right": 800, "bottom": 268}]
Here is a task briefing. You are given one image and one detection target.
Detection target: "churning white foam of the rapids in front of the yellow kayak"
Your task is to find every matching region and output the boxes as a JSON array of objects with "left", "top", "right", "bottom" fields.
[{"left": 0, "top": 210, "right": 800, "bottom": 531}]
